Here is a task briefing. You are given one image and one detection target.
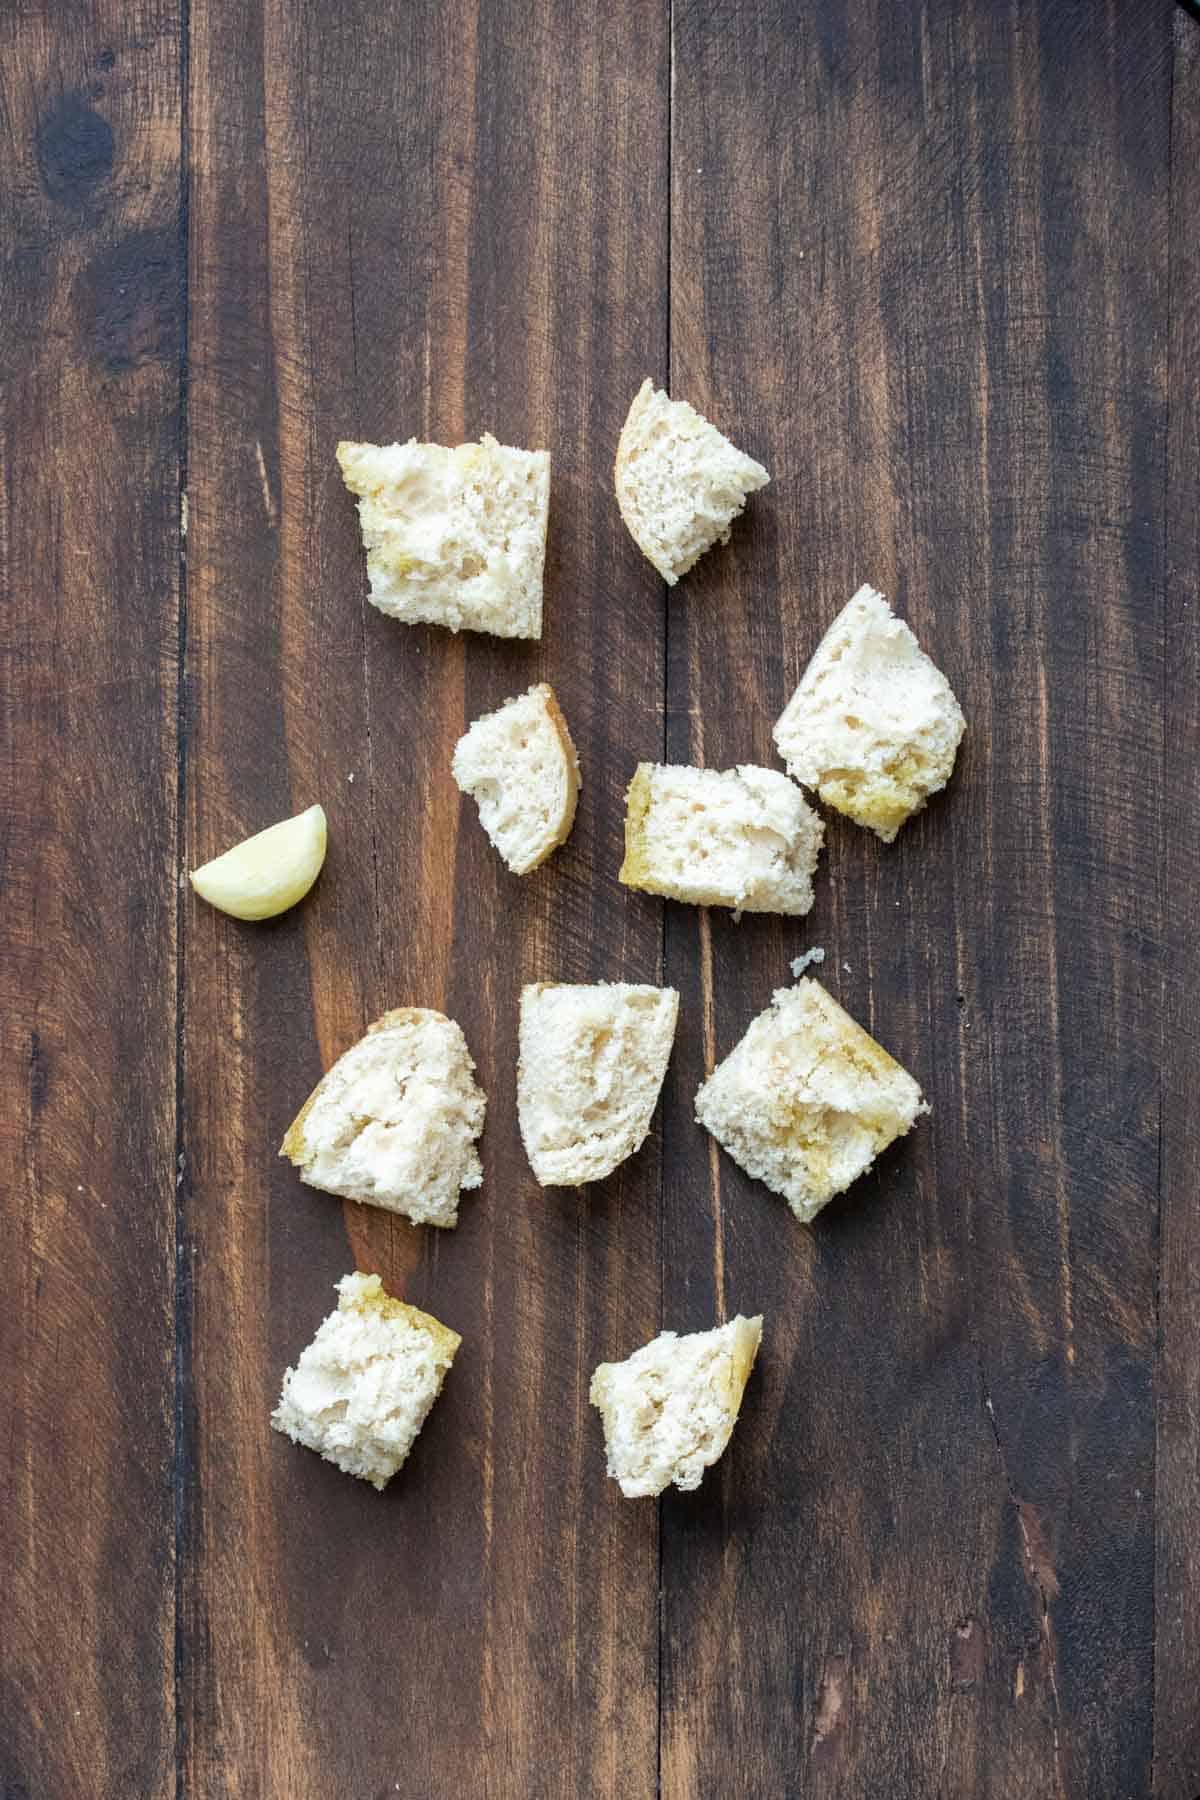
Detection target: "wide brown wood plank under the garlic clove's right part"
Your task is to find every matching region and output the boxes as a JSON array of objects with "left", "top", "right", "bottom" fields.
[{"left": 182, "top": 0, "right": 667, "bottom": 1800}]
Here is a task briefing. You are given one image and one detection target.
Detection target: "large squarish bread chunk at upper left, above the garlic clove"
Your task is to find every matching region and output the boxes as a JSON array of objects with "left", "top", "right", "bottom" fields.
[{"left": 338, "top": 434, "right": 551, "bottom": 637}]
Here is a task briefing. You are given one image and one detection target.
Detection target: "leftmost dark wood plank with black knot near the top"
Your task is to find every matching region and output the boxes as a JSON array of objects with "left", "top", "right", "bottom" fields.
[{"left": 0, "top": 0, "right": 184, "bottom": 1800}]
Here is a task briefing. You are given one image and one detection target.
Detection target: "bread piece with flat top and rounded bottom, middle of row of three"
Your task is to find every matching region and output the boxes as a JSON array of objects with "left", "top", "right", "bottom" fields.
[{"left": 516, "top": 981, "right": 678, "bottom": 1188}]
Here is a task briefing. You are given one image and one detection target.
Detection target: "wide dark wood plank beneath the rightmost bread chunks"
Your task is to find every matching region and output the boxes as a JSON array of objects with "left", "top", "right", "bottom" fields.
[{"left": 662, "top": 0, "right": 1165, "bottom": 1800}]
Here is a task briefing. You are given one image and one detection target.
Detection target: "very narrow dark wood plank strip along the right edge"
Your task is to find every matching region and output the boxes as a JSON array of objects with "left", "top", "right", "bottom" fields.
[{"left": 1155, "top": 13, "right": 1200, "bottom": 1800}]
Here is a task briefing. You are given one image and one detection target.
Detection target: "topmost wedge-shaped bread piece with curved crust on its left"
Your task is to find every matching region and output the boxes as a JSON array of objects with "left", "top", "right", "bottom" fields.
[{"left": 615, "top": 380, "right": 770, "bottom": 587}]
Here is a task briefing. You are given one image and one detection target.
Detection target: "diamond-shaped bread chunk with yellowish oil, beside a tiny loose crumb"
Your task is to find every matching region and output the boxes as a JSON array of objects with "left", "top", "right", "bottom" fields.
[{"left": 696, "top": 977, "right": 928, "bottom": 1220}]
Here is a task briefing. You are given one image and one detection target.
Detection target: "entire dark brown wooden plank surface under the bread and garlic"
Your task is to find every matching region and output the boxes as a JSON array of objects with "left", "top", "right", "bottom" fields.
[{"left": 0, "top": 0, "right": 1200, "bottom": 1800}]
